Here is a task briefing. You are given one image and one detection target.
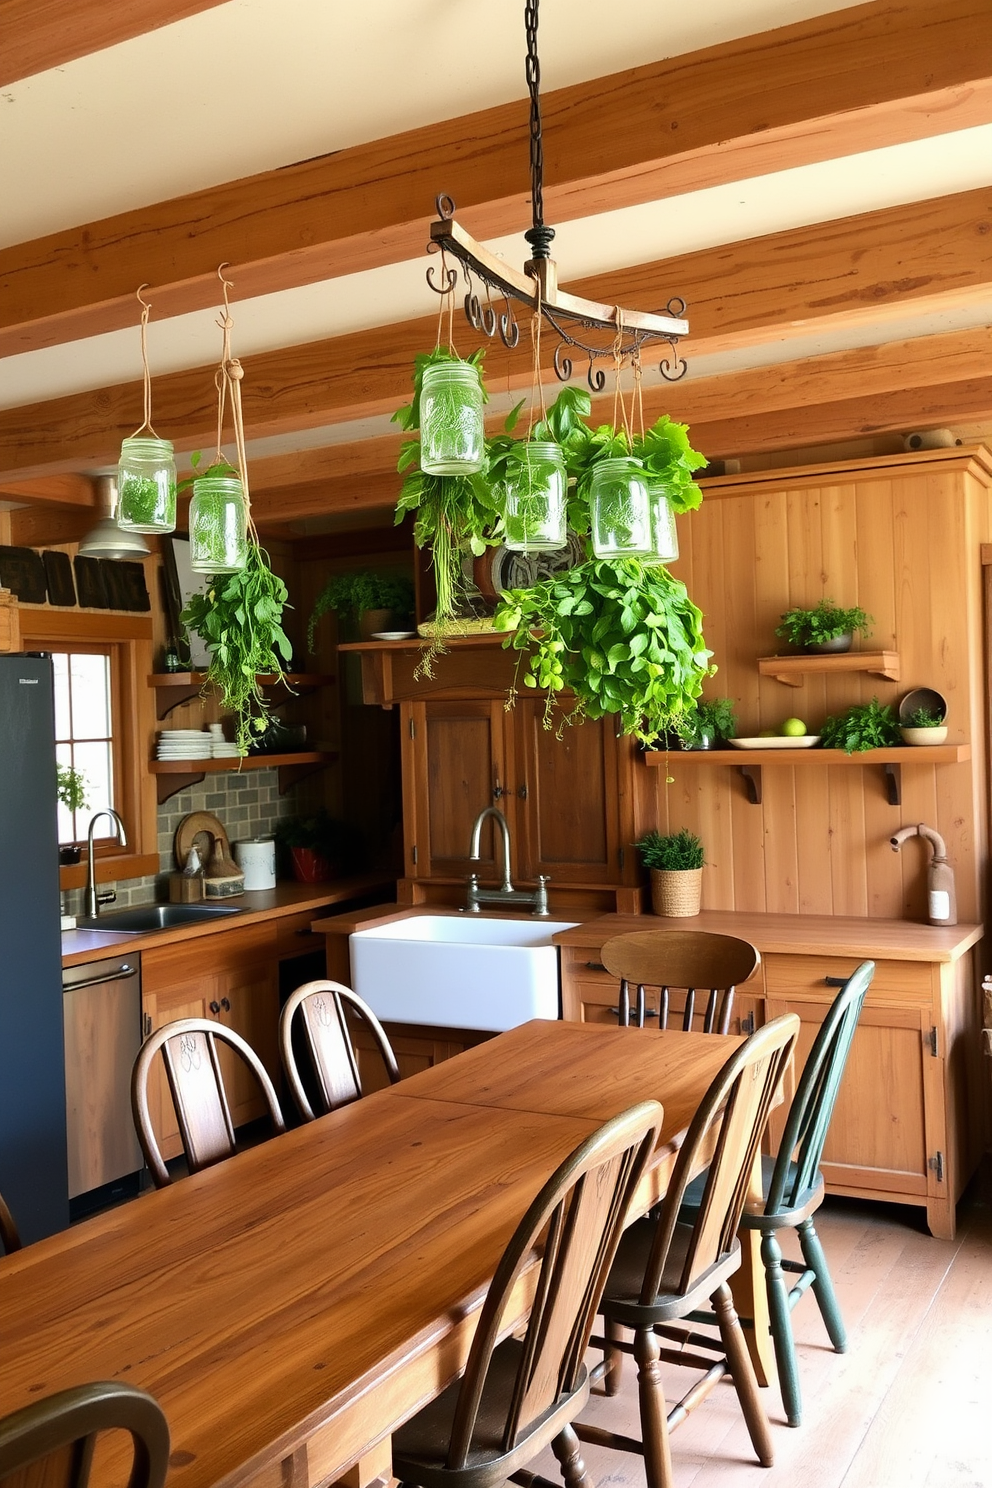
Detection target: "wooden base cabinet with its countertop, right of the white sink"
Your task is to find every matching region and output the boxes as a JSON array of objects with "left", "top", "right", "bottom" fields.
[{"left": 556, "top": 911, "right": 985, "bottom": 1238}]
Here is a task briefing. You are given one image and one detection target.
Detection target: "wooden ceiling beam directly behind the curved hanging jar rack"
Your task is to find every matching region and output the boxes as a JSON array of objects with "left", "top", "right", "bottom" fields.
[{"left": 0, "top": 187, "right": 992, "bottom": 485}]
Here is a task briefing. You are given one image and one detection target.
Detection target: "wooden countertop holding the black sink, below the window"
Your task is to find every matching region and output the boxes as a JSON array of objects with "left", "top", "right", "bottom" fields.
[{"left": 62, "top": 873, "right": 396, "bottom": 966}]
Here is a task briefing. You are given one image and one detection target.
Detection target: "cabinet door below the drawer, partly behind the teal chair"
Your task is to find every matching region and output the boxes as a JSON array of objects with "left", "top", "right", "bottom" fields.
[{"left": 766, "top": 998, "right": 930, "bottom": 1196}]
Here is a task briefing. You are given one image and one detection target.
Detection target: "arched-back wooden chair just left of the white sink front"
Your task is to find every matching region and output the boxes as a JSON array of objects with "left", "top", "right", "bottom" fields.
[{"left": 280, "top": 982, "right": 400, "bottom": 1120}]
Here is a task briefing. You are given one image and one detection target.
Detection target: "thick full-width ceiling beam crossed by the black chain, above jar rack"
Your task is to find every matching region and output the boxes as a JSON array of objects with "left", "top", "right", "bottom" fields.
[{"left": 0, "top": 0, "right": 992, "bottom": 354}]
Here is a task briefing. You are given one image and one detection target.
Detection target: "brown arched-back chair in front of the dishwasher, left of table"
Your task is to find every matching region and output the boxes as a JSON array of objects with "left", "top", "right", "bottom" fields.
[{"left": 131, "top": 1018, "right": 286, "bottom": 1189}]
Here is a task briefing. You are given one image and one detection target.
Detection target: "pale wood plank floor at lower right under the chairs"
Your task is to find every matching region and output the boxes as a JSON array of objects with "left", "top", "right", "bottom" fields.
[{"left": 534, "top": 1173, "right": 992, "bottom": 1488}]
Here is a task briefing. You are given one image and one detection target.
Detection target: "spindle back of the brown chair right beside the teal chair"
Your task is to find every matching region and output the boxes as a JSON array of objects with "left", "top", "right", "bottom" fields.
[{"left": 641, "top": 1013, "right": 800, "bottom": 1306}]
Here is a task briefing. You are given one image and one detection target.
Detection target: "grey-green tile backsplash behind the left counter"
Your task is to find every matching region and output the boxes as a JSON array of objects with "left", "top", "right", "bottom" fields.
[{"left": 62, "top": 766, "right": 303, "bottom": 915}]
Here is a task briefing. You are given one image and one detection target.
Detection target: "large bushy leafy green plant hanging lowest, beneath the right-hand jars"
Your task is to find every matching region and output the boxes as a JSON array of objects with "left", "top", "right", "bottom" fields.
[{"left": 495, "top": 559, "right": 711, "bottom": 744}]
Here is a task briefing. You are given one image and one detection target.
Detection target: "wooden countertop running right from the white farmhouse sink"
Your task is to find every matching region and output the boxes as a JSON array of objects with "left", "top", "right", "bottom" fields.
[{"left": 553, "top": 909, "right": 983, "bottom": 961}]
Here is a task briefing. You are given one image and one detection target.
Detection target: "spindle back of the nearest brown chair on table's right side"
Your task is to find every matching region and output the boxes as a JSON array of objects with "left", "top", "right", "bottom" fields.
[{"left": 446, "top": 1101, "right": 663, "bottom": 1469}]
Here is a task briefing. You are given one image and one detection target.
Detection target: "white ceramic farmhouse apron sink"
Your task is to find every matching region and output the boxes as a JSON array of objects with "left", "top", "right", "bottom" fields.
[{"left": 350, "top": 915, "right": 576, "bottom": 1033}]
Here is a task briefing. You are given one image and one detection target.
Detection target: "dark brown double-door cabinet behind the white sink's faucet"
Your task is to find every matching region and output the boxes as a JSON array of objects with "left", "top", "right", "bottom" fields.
[{"left": 402, "top": 698, "right": 637, "bottom": 893}]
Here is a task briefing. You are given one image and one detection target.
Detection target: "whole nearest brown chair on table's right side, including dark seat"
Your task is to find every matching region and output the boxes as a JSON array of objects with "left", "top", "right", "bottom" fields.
[{"left": 393, "top": 1101, "right": 662, "bottom": 1488}]
